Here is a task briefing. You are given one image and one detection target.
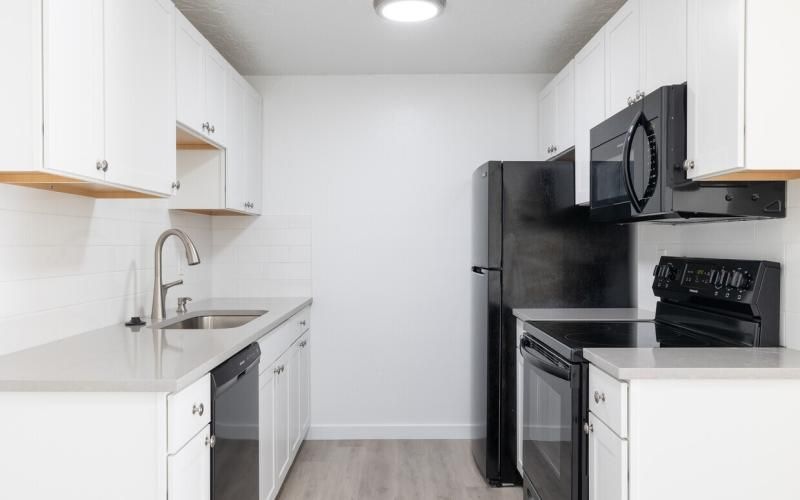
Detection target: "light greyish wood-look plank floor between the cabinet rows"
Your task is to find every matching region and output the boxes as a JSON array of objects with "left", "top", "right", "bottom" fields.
[{"left": 278, "top": 440, "right": 522, "bottom": 500}]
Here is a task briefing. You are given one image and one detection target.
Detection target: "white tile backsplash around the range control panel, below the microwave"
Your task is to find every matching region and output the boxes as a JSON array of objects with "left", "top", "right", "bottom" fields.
[{"left": 637, "top": 180, "right": 800, "bottom": 349}]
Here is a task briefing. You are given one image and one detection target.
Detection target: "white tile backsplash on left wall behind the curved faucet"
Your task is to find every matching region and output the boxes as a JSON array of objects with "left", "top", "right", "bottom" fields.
[{"left": 0, "top": 185, "right": 211, "bottom": 354}]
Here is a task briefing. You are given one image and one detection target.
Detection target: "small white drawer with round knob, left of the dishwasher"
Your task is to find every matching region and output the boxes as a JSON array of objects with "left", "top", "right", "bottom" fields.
[{"left": 167, "top": 375, "right": 211, "bottom": 454}]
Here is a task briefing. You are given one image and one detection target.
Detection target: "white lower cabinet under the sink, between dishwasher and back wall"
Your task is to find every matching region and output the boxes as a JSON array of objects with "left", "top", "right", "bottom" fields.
[{"left": 259, "top": 311, "right": 311, "bottom": 500}]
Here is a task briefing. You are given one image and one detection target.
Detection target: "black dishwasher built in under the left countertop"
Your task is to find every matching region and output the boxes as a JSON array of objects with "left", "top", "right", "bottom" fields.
[{"left": 211, "top": 343, "right": 261, "bottom": 500}]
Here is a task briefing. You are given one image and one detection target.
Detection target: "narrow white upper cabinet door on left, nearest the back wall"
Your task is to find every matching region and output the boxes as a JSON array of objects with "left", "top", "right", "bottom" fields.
[{"left": 244, "top": 88, "right": 264, "bottom": 214}]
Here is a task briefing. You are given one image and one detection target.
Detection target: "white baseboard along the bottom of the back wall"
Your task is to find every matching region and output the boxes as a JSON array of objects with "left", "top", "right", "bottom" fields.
[{"left": 307, "top": 424, "right": 479, "bottom": 441}]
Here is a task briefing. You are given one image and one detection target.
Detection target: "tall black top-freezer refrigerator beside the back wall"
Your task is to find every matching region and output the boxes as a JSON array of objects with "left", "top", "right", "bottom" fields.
[{"left": 471, "top": 162, "right": 636, "bottom": 486}]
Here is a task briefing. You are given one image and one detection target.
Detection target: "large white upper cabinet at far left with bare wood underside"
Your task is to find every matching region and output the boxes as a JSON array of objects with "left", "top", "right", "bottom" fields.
[{"left": 0, "top": 0, "right": 175, "bottom": 198}]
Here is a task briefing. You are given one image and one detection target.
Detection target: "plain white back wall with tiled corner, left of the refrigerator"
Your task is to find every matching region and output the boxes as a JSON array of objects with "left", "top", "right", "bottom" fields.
[{"left": 225, "top": 75, "right": 548, "bottom": 438}]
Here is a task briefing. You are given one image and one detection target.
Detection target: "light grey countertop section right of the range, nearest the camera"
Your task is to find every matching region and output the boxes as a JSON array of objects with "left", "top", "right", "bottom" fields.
[{"left": 583, "top": 347, "right": 800, "bottom": 380}]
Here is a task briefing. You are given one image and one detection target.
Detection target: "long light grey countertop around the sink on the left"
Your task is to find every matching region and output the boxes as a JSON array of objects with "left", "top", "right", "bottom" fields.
[{"left": 0, "top": 298, "right": 311, "bottom": 392}]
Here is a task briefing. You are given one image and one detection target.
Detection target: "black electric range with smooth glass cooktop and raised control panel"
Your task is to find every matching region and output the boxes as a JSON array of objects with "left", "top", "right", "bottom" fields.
[{"left": 520, "top": 257, "right": 780, "bottom": 500}]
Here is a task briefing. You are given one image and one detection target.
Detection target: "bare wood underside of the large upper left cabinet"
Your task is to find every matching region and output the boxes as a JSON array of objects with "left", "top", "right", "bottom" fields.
[{"left": 0, "top": 172, "right": 159, "bottom": 198}]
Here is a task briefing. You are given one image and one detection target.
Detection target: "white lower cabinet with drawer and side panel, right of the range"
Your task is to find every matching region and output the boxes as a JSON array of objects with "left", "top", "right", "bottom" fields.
[{"left": 584, "top": 364, "right": 800, "bottom": 500}]
